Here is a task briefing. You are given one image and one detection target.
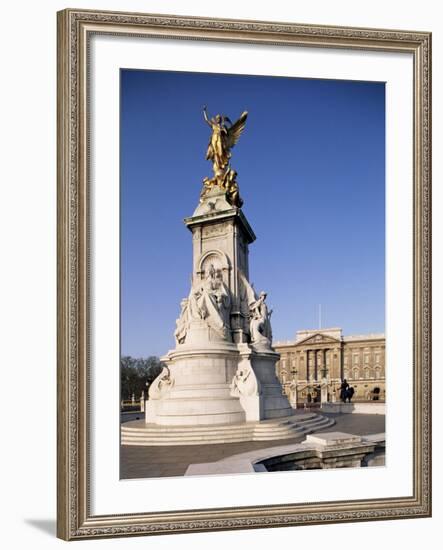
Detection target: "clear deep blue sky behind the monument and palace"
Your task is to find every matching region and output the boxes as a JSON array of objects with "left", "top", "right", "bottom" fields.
[{"left": 120, "top": 70, "right": 385, "bottom": 357}]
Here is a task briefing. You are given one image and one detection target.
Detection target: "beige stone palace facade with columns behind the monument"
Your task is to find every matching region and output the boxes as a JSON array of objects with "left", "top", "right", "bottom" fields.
[{"left": 273, "top": 328, "right": 386, "bottom": 407}]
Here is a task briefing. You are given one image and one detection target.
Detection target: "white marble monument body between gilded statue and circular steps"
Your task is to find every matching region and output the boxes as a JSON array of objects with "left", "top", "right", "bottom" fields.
[{"left": 145, "top": 187, "right": 293, "bottom": 426}]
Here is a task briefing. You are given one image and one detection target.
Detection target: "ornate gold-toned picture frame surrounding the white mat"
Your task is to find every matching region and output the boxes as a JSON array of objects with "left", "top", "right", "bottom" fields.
[{"left": 57, "top": 9, "right": 431, "bottom": 540}]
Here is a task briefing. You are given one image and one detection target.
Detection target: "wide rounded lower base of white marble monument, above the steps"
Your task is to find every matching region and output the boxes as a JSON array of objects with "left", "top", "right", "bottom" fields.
[{"left": 146, "top": 344, "right": 293, "bottom": 426}]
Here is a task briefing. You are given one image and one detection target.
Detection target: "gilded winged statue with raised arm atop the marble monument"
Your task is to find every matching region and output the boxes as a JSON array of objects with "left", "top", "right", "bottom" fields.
[{"left": 201, "top": 106, "right": 248, "bottom": 207}]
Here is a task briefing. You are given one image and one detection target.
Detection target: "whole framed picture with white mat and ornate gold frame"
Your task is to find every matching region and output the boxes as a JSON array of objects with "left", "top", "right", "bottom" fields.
[{"left": 57, "top": 9, "right": 431, "bottom": 540}]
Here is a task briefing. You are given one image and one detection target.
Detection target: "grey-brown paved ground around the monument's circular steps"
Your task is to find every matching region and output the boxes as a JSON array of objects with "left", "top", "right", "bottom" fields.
[{"left": 120, "top": 413, "right": 385, "bottom": 479}]
